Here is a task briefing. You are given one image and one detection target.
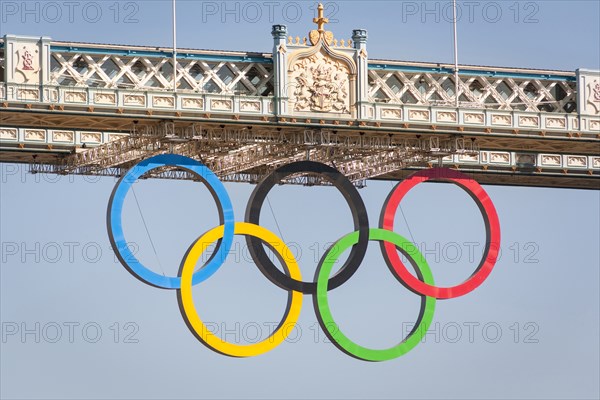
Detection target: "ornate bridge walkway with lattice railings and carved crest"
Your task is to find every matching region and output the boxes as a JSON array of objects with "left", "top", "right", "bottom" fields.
[{"left": 0, "top": 9, "right": 600, "bottom": 189}]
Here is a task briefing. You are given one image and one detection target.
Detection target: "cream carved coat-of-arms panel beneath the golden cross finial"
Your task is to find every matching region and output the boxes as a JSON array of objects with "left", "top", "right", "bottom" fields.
[{"left": 289, "top": 52, "right": 350, "bottom": 114}]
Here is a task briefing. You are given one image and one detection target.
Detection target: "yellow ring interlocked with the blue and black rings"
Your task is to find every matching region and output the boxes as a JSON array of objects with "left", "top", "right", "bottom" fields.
[{"left": 178, "top": 222, "right": 302, "bottom": 357}]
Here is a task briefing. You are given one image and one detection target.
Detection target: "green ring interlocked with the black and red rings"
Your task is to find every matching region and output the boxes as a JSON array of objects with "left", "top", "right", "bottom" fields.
[{"left": 313, "top": 228, "right": 435, "bottom": 361}]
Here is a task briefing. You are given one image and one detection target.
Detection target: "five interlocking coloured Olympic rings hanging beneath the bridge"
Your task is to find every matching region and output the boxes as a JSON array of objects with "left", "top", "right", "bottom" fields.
[{"left": 106, "top": 154, "right": 500, "bottom": 361}]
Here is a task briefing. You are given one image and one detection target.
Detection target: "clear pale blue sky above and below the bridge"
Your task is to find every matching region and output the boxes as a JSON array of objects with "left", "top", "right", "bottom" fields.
[{"left": 0, "top": 0, "right": 600, "bottom": 398}]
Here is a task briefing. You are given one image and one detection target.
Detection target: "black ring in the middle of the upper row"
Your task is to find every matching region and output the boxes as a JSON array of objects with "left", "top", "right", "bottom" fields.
[{"left": 246, "top": 161, "right": 369, "bottom": 294}]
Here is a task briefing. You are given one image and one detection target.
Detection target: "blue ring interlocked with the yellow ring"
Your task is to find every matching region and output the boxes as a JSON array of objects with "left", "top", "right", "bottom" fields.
[{"left": 106, "top": 154, "right": 235, "bottom": 289}]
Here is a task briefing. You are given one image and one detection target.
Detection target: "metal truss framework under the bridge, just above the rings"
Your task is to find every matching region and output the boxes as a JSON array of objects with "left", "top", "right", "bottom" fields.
[{"left": 36, "top": 123, "right": 479, "bottom": 186}]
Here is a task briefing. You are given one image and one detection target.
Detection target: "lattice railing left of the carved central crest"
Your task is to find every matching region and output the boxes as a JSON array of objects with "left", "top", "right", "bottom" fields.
[{"left": 50, "top": 47, "right": 273, "bottom": 96}]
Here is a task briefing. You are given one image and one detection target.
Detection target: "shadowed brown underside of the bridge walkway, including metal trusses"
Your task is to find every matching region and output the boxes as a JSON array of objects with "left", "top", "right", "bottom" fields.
[{"left": 0, "top": 105, "right": 600, "bottom": 189}]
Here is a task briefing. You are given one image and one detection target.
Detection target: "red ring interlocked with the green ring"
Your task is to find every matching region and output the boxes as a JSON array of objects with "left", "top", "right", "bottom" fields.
[{"left": 380, "top": 168, "right": 500, "bottom": 299}]
